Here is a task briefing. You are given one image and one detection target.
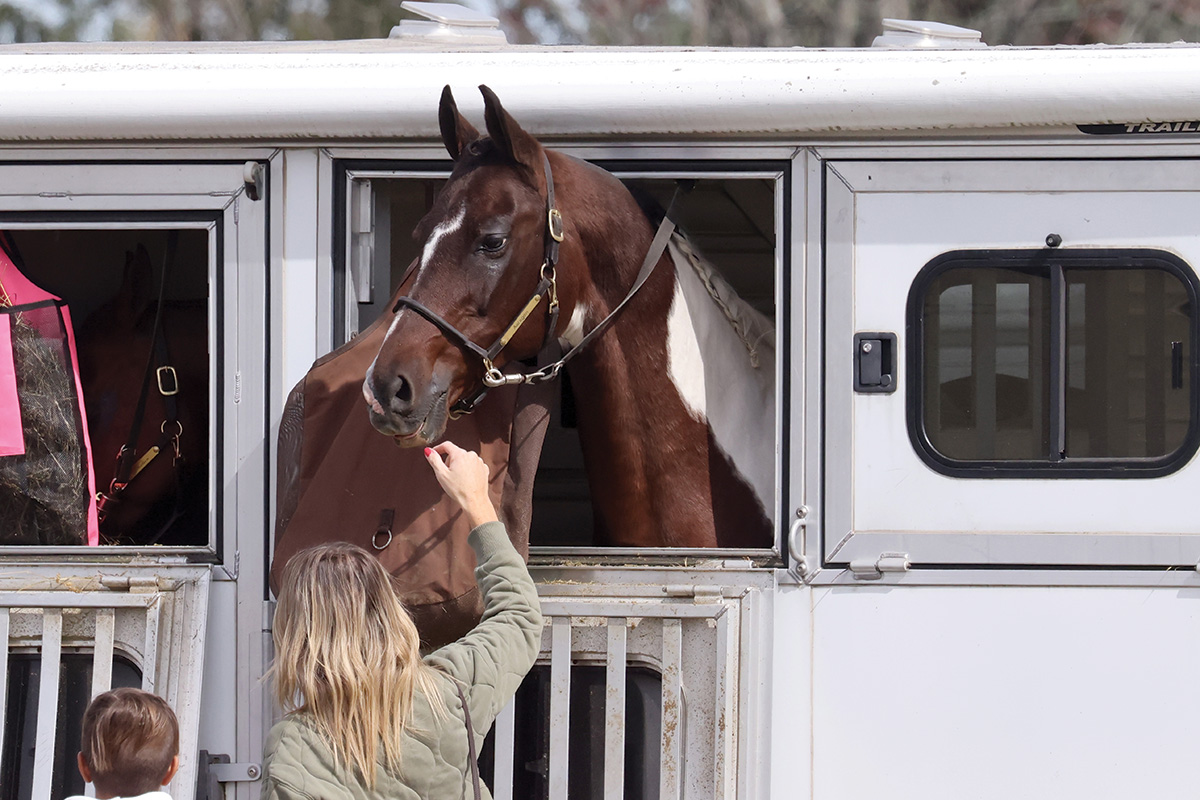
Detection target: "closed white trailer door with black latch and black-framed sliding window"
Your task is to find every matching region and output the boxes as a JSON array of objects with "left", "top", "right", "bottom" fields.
[{"left": 823, "top": 160, "right": 1200, "bottom": 578}]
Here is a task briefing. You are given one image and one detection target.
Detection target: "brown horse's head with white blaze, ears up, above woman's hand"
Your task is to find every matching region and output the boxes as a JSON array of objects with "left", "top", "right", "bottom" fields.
[{"left": 362, "top": 86, "right": 592, "bottom": 447}]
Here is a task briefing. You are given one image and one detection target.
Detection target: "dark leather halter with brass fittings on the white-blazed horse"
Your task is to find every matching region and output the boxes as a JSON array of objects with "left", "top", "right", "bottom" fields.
[{"left": 391, "top": 152, "right": 681, "bottom": 420}]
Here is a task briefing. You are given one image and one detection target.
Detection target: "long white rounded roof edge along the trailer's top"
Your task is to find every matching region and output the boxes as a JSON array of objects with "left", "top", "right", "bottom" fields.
[{"left": 0, "top": 40, "right": 1200, "bottom": 143}]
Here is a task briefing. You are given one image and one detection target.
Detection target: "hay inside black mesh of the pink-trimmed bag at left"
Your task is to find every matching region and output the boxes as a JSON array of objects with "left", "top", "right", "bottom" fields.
[{"left": 0, "top": 306, "right": 89, "bottom": 545}]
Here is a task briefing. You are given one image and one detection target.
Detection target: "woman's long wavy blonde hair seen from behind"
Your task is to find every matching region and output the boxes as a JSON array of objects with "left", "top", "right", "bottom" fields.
[{"left": 271, "top": 543, "right": 445, "bottom": 788}]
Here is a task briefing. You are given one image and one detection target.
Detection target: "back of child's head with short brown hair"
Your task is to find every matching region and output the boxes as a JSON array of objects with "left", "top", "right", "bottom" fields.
[{"left": 67, "top": 688, "right": 179, "bottom": 800}]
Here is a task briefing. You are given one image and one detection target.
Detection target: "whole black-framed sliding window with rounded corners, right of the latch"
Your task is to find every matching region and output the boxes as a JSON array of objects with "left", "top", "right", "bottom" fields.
[{"left": 908, "top": 251, "right": 1196, "bottom": 477}]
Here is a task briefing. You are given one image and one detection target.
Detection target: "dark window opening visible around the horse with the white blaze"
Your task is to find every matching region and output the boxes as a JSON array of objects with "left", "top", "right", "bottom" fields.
[{"left": 332, "top": 158, "right": 791, "bottom": 558}]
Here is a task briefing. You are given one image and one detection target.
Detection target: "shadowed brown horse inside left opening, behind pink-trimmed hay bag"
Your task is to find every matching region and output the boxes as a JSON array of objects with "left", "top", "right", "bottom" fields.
[{"left": 77, "top": 243, "right": 209, "bottom": 545}]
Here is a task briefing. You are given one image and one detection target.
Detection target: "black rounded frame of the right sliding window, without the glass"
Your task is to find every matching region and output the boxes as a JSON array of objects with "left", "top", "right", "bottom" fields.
[{"left": 905, "top": 247, "right": 1200, "bottom": 479}]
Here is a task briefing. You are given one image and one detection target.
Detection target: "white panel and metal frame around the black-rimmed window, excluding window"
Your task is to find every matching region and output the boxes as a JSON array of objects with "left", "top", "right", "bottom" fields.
[{"left": 820, "top": 153, "right": 1200, "bottom": 575}]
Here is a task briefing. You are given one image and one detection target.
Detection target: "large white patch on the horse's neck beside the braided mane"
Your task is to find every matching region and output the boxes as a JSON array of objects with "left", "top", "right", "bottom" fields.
[{"left": 667, "top": 236, "right": 775, "bottom": 522}]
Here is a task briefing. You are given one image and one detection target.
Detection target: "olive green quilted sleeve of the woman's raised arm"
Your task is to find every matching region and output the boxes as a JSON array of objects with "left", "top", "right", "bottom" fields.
[{"left": 426, "top": 522, "right": 542, "bottom": 735}]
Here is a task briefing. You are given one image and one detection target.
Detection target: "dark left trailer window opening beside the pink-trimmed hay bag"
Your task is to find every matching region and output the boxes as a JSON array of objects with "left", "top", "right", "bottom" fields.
[{"left": 0, "top": 227, "right": 212, "bottom": 548}]
